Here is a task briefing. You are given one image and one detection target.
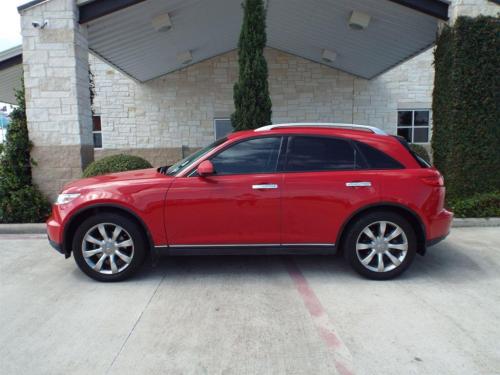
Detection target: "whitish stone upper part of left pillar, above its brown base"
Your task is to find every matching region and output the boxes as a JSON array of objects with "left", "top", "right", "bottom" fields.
[{"left": 21, "top": 0, "right": 92, "bottom": 146}]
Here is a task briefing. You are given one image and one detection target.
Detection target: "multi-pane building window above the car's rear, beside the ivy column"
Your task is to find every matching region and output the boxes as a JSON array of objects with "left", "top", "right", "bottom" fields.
[{"left": 398, "top": 109, "right": 431, "bottom": 143}]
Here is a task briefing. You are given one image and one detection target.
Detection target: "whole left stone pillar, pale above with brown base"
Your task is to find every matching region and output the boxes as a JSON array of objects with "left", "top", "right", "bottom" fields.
[{"left": 21, "top": 0, "right": 94, "bottom": 198}]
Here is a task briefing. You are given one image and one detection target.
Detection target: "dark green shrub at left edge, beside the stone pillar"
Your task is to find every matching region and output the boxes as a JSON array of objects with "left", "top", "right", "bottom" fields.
[{"left": 0, "top": 81, "right": 50, "bottom": 223}]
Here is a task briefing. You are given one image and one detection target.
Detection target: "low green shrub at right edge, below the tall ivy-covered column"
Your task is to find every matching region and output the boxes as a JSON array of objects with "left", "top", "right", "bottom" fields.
[{"left": 449, "top": 191, "right": 500, "bottom": 217}]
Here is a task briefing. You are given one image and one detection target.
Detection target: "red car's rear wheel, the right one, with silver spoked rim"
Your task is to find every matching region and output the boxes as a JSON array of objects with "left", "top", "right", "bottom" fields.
[{"left": 344, "top": 212, "right": 417, "bottom": 280}]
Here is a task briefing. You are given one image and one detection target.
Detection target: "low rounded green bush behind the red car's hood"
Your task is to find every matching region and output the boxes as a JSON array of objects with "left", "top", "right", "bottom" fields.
[{"left": 83, "top": 154, "right": 152, "bottom": 177}]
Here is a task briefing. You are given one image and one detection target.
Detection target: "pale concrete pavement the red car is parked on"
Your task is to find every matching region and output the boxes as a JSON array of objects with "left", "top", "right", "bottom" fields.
[{"left": 0, "top": 227, "right": 500, "bottom": 375}]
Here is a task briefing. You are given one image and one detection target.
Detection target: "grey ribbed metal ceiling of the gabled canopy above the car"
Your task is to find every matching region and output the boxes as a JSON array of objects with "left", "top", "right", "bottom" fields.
[{"left": 86, "top": 0, "right": 447, "bottom": 81}]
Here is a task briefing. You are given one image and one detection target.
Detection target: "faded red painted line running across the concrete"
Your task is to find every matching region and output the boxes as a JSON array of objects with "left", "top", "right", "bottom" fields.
[{"left": 284, "top": 257, "right": 354, "bottom": 375}]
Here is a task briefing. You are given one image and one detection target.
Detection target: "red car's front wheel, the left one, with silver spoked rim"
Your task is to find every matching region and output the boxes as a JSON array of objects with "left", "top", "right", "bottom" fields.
[{"left": 73, "top": 213, "right": 146, "bottom": 281}]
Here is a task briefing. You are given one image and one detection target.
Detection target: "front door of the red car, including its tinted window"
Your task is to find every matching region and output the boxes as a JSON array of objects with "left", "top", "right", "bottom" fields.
[{"left": 165, "top": 136, "right": 283, "bottom": 247}]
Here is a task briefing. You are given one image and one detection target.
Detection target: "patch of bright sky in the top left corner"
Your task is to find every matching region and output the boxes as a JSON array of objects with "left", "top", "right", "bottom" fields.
[{"left": 0, "top": 0, "right": 29, "bottom": 52}]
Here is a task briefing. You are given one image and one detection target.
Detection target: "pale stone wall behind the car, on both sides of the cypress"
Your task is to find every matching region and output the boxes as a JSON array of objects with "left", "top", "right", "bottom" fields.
[{"left": 90, "top": 44, "right": 434, "bottom": 165}]
